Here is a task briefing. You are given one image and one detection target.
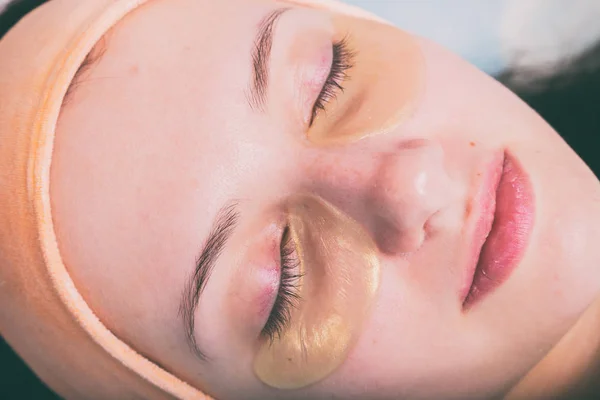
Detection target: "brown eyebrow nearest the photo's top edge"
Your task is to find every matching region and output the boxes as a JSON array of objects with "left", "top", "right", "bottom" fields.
[{"left": 248, "top": 7, "right": 290, "bottom": 111}]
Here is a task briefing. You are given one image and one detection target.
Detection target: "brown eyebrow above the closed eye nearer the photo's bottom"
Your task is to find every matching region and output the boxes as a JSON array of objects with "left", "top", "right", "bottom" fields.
[{"left": 179, "top": 202, "right": 239, "bottom": 361}]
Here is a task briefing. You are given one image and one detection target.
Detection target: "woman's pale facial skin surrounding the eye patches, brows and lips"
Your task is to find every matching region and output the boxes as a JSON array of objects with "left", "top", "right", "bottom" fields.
[{"left": 51, "top": 0, "right": 600, "bottom": 399}]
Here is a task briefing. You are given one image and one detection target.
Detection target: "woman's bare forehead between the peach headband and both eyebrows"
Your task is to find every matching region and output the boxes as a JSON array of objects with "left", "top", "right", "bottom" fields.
[{"left": 51, "top": 0, "right": 276, "bottom": 341}]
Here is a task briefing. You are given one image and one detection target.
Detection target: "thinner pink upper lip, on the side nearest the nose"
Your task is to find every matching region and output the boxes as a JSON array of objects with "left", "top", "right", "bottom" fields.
[{"left": 460, "top": 151, "right": 505, "bottom": 304}]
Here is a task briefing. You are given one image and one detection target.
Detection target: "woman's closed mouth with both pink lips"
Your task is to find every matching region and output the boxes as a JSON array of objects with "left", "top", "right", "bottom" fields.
[{"left": 460, "top": 152, "right": 534, "bottom": 310}]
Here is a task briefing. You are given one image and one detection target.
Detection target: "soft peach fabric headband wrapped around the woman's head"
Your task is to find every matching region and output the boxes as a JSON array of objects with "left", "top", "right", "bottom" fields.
[{"left": 0, "top": 0, "right": 384, "bottom": 399}]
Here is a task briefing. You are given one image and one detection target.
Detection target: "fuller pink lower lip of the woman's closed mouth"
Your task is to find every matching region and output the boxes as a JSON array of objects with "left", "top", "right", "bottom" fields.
[{"left": 463, "top": 153, "right": 534, "bottom": 309}]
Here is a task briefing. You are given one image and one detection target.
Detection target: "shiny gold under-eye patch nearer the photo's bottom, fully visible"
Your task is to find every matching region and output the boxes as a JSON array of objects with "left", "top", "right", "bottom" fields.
[{"left": 254, "top": 195, "right": 380, "bottom": 389}]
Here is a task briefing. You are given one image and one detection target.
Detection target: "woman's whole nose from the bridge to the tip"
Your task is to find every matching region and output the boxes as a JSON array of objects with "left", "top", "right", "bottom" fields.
[{"left": 300, "top": 139, "right": 460, "bottom": 255}]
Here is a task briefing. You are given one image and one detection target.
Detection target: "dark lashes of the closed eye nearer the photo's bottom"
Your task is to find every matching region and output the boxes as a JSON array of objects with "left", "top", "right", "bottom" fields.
[{"left": 262, "top": 227, "right": 302, "bottom": 342}]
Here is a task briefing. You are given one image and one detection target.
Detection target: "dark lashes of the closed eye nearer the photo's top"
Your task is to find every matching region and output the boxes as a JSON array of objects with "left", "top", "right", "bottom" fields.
[{"left": 309, "top": 37, "right": 355, "bottom": 126}]
